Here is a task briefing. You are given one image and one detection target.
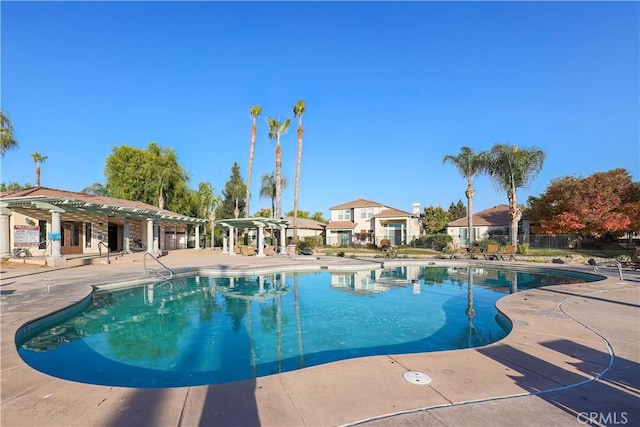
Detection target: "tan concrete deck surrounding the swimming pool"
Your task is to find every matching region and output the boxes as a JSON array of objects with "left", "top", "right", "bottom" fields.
[{"left": 0, "top": 250, "right": 640, "bottom": 427}]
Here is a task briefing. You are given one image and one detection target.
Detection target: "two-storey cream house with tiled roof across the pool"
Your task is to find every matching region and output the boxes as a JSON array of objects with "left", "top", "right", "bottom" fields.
[{"left": 326, "top": 199, "right": 420, "bottom": 246}]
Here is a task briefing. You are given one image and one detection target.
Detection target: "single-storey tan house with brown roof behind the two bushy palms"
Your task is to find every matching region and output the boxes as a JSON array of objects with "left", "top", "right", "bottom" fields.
[{"left": 446, "top": 205, "right": 530, "bottom": 248}]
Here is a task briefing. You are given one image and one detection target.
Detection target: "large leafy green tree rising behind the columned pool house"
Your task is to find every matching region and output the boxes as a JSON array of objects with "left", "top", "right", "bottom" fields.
[{"left": 105, "top": 142, "right": 190, "bottom": 216}]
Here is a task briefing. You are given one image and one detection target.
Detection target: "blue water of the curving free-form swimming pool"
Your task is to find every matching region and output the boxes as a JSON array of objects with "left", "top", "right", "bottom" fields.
[{"left": 17, "top": 266, "right": 594, "bottom": 388}]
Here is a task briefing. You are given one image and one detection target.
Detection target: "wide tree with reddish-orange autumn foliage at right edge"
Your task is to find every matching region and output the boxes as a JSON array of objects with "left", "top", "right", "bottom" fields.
[{"left": 528, "top": 169, "right": 640, "bottom": 237}]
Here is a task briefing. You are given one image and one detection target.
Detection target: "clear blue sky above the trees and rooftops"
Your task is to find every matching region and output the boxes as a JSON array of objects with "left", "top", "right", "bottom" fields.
[{"left": 0, "top": 1, "right": 640, "bottom": 216}]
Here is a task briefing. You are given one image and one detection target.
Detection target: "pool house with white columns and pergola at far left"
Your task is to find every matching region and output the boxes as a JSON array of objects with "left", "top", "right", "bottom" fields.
[{"left": 0, "top": 187, "right": 206, "bottom": 266}]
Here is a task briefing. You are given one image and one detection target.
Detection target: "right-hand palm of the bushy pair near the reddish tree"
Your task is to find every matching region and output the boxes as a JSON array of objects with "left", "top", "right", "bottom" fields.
[{"left": 483, "top": 144, "right": 545, "bottom": 245}]
